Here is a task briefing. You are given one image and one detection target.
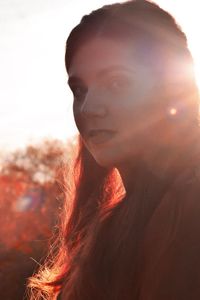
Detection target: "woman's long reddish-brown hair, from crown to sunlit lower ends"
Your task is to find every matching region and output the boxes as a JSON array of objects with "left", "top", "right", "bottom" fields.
[{"left": 29, "top": 0, "right": 199, "bottom": 300}]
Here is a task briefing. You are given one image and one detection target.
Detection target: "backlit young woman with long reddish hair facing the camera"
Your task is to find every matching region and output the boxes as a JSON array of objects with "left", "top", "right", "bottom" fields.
[{"left": 29, "top": 0, "right": 200, "bottom": 300}]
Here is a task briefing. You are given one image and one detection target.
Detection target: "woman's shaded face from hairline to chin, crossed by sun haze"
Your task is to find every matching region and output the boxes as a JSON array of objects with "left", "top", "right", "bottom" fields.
[{"left": 69, "top": 38, "right": 162, "bottom": 167}]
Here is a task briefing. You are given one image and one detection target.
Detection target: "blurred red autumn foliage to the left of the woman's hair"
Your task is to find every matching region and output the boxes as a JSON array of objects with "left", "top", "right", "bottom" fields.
[{"left": 0, "top": 140, "right": 72, "bottom": 300}]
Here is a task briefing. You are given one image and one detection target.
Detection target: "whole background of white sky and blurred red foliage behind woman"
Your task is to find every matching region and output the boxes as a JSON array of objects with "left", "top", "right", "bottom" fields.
[{"left": 0, "top": 0, "right": 200, "bottom": 300}]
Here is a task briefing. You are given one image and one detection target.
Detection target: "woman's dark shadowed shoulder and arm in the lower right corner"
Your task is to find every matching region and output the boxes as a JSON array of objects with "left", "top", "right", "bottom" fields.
[{"left": 139, "top": 169, "right": 200, "bottom": 300}]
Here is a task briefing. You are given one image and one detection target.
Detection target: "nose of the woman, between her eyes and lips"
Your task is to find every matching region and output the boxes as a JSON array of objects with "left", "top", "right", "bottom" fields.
[{"left": 80, "top": 88, "right": 107, "bottom": 118}]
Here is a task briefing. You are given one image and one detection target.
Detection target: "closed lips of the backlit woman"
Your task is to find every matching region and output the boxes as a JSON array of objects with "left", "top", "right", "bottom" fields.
[{"left": 88, "top": 129, "right": 116, "bottom": 144}]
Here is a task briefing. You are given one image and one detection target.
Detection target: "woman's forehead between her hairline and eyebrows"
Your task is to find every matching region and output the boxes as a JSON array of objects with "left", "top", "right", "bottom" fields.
[{"left": 68, "top": 38, "right": 141, "bottom": 78}]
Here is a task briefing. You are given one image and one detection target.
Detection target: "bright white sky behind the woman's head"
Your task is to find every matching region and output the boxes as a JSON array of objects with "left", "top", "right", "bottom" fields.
[{"left": 0, "top": 0, "right": 200, "bottom": 152}]
